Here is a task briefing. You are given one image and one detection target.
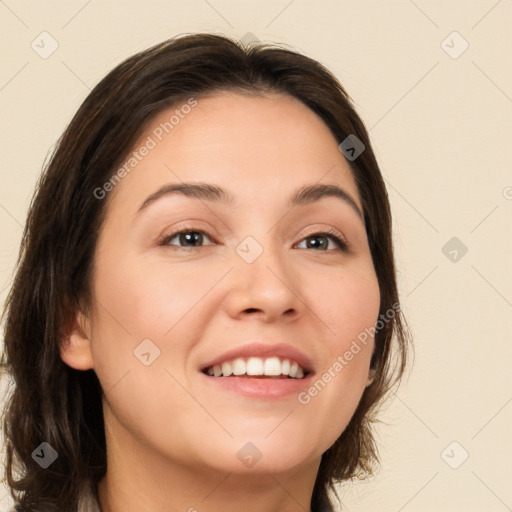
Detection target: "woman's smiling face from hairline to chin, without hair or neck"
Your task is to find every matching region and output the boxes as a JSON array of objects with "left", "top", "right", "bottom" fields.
[{"left": 63, "top": 93, "right": 380, "bottom": 473}]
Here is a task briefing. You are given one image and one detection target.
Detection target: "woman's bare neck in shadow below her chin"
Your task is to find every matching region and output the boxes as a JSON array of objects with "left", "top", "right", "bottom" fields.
[{"left": 98, "top": 410, "right": 320, "bottom": 512}]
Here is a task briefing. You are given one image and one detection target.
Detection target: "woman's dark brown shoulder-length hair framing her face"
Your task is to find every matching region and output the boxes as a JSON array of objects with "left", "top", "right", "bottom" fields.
[{"left": 2, "top": 34, "right": 409, "bottom": 512}]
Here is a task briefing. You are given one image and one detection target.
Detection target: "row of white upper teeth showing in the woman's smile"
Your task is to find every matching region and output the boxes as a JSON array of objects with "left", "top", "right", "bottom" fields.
[{"left": 206, "top": 356, "right": 304, "bottom": 379}]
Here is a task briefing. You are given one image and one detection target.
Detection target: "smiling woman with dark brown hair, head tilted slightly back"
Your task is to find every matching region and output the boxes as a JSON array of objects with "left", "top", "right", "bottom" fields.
[{"left": 0, "top": 34, "right": 409, "bottom": 512}]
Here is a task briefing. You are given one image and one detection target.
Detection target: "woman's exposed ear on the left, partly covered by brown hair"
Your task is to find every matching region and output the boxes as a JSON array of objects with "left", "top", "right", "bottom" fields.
[{"left": 60, "top": 312, "right": 94, "bottom": 370}]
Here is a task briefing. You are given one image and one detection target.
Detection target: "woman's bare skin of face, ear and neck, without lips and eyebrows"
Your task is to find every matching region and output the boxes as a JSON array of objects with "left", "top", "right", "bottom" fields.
[{"left": 61, "top": 93, "right": 380, "bottom": 512}]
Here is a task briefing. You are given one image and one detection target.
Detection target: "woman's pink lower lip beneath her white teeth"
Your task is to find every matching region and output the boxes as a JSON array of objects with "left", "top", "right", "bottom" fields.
[{"left": 201, "top": 373, "right": 312, "bottom": 399}]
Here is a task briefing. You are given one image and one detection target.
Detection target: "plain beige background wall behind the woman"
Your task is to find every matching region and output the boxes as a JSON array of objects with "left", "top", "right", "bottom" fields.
[{"left": 0, "top": 0, "right": 512, "bottom": 512}]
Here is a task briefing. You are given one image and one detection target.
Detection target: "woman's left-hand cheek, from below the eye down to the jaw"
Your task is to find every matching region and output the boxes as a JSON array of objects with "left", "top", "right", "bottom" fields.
[{"left": 92, "top": 255, "right": 218, "bottom": 452}]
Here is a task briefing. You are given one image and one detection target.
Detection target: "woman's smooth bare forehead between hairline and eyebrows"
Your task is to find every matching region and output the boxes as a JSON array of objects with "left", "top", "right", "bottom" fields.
[{"left": 103, "top": 92, "right": 360, "bottom": 218}]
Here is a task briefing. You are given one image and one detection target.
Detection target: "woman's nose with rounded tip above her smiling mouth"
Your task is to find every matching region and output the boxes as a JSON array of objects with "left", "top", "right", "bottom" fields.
[{"left": 225, "top": 241, "right": 304, "bottom": 323}]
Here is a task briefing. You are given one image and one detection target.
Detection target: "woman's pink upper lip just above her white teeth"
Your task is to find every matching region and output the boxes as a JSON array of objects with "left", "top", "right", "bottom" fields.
[{"left": 201, "top": 342, "right": 313, "bottom": 373}]
